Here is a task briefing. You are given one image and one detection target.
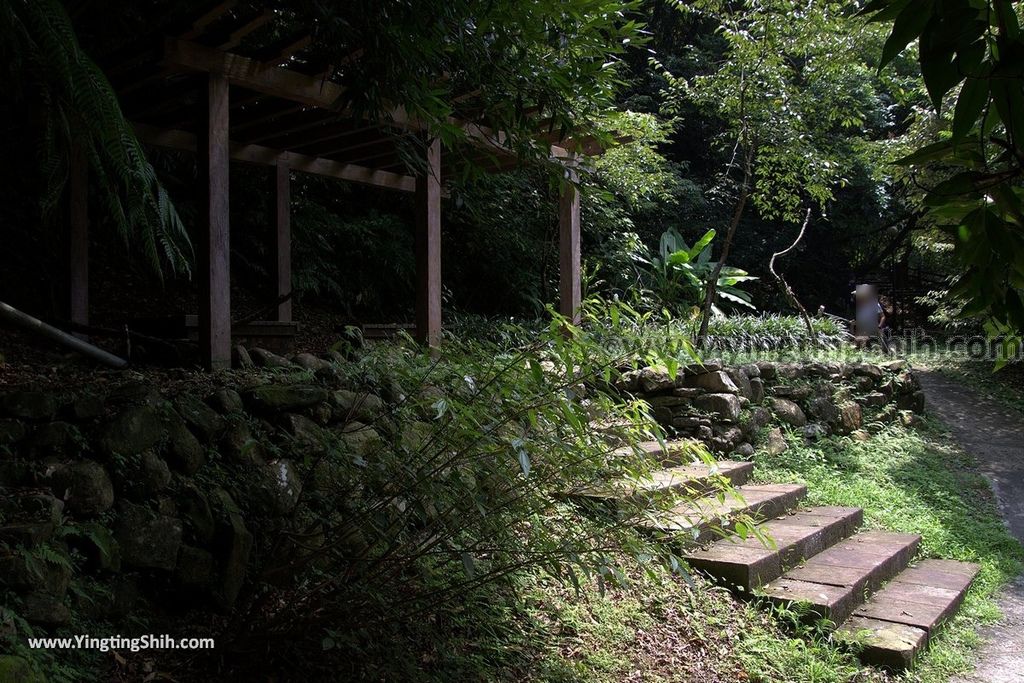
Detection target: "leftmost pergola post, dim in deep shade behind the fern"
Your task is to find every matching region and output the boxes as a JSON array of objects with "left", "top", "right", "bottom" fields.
[{"left": 68, "top": 144, "right": 89, "bottom": 339}]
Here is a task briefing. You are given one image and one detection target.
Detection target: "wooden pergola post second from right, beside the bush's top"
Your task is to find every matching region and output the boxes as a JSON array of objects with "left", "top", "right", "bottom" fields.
[{"left": 416, "top": 139, "right": 441, "bottom": 346}]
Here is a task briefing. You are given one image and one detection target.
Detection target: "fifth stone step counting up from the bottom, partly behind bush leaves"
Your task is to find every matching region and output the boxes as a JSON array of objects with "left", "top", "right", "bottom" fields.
[{"left": 579, "top": 460, "right": 754, "bottom": 505}]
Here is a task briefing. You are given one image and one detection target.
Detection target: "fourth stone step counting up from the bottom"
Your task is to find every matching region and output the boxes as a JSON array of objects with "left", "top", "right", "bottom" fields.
[{"left": 638, "top": 483, "right": 807, "bottom": 543}]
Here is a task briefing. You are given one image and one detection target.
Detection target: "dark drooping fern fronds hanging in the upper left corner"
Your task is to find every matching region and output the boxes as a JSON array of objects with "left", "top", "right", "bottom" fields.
[{"left": 0, "top": 0, "right": 191, "bottom": 274}]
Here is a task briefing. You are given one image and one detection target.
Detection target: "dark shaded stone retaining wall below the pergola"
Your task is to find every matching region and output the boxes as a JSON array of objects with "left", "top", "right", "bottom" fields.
[{"left": 0, "top": 349, "right": 411, "bottom": 627}]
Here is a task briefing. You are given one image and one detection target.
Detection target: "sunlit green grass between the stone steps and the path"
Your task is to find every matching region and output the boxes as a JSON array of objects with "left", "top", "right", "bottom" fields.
[{"left": 755, "top": 422, "right": 1024, "bottom": 682}]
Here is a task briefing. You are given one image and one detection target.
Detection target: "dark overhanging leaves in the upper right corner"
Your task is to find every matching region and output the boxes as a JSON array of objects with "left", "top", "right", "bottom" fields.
[{"left": 863, "top": 0, "right": 1024, "bottom": 347}]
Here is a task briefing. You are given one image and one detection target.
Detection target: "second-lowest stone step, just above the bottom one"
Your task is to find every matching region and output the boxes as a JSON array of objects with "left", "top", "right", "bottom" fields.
[{"left": 757, "top": 531, "right": 921, "bottom": 624}]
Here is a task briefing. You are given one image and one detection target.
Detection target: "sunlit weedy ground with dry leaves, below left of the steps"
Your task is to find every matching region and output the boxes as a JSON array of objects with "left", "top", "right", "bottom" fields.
[{"left": 511, "top": 561, "right": 886, "bottom": 683}]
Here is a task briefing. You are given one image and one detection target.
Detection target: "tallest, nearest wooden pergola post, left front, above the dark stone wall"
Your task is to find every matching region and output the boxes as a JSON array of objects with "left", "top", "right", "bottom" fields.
[{"left": 197, "top": 74, "right": 231, "bottom": 370}]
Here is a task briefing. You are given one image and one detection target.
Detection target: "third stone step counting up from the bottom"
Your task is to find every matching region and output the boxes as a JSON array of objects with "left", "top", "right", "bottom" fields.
[{"left": 683, "top": 507, "right": 864, "bottom": 591}]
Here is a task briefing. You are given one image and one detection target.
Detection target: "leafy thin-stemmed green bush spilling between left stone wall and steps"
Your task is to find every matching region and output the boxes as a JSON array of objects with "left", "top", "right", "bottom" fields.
[{"left": 218, "top": 304, "right": 727, "bottom": 678}]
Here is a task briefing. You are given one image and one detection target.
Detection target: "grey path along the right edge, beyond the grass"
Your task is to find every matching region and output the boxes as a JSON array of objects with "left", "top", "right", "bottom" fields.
[{"left": 918, "top": 373, "right": 1024, "bottom": 683}]
